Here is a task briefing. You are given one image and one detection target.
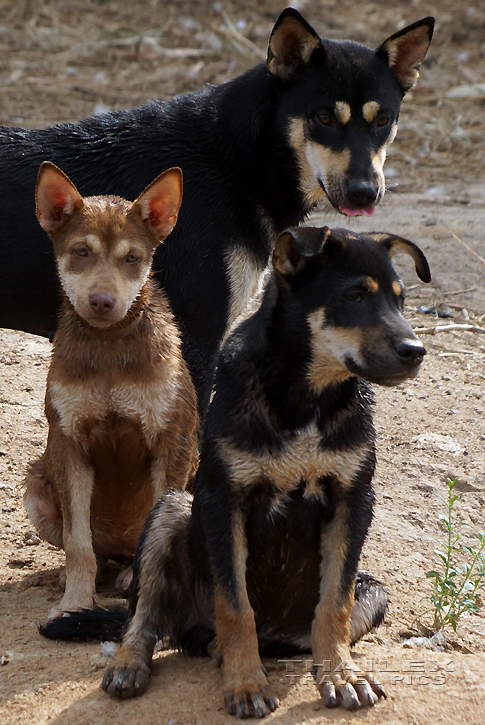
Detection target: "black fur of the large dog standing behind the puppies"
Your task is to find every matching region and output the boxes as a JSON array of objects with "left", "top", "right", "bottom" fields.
[{"left": 0, "top": 10, "right": 432, "bottom": 411}]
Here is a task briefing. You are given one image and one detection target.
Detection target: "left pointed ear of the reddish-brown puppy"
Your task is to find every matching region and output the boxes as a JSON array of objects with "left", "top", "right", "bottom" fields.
[{"left": 35, "top": 161, "right": 83, "bottom": 234}]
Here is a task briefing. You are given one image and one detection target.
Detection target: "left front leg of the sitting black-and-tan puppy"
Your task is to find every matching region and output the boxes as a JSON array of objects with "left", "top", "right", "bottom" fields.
[{"left": 207, "top": 509, "right": 279, "bottom": 718}]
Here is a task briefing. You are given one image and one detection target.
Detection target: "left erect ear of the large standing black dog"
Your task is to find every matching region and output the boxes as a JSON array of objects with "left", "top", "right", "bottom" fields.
[{"left": 267, "top": 8, "right": 321, "bottom": 81}]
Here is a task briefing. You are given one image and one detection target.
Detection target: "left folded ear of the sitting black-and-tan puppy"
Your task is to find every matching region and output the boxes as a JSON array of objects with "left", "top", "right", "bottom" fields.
[{"left": 273, "top": 227, "right": 330, "bottom": 279}]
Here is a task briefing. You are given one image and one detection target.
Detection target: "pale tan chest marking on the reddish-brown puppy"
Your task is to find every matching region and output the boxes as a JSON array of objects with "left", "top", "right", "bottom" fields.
[{"left": 48, "top": 370, "right": 179, "bottom": 446}]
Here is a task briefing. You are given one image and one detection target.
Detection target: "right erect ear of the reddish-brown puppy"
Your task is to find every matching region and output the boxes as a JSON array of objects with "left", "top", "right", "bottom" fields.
[{"left": 131, "top": 166, "right": 182, "bottom": 244}]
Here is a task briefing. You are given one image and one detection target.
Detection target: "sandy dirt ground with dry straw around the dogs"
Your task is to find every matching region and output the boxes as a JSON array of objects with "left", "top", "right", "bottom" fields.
[{"left": 0, "top": 0, "right": 485, "bottom": 725}]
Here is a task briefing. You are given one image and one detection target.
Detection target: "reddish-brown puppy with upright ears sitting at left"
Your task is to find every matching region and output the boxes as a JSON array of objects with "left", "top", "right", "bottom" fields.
[{"left": 25, "top": 162, "right": 198, "bottom": 618}]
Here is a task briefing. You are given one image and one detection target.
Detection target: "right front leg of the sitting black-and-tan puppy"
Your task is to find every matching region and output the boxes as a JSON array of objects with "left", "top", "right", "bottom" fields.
[{"left": 311, "top": 500, "right": 385, "bottom": 710}]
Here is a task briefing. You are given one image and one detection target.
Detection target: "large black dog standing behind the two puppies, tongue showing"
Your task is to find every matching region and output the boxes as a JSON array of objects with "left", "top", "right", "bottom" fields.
[{"left": 0, "top": 9, "right": 433, "bottom": 409}]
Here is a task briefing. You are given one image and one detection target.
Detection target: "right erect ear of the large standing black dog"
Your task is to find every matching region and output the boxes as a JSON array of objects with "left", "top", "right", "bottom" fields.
[{"left": 376, "top": 17, "right": 434, "bottom": 93}]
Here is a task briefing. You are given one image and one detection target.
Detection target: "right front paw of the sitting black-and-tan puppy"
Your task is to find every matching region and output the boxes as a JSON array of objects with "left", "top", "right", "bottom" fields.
[{"left": 315, "top": 667, "right": 387, "bottom": 710}]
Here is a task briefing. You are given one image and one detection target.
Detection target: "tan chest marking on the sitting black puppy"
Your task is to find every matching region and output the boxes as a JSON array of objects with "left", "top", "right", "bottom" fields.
[{"left": 220, "top": 424, "right": 369, "bottom": 496}]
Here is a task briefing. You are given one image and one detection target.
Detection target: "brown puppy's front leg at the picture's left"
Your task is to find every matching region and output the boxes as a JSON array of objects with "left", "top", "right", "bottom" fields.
[{"left": 49, "top": 450, "right": 97, "bottom": 619}]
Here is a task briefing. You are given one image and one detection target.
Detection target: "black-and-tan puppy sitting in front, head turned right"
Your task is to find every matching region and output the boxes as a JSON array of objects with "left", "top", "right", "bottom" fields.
[{"left": 42, "top": 227, "right": 430, "bottom": 717}]
